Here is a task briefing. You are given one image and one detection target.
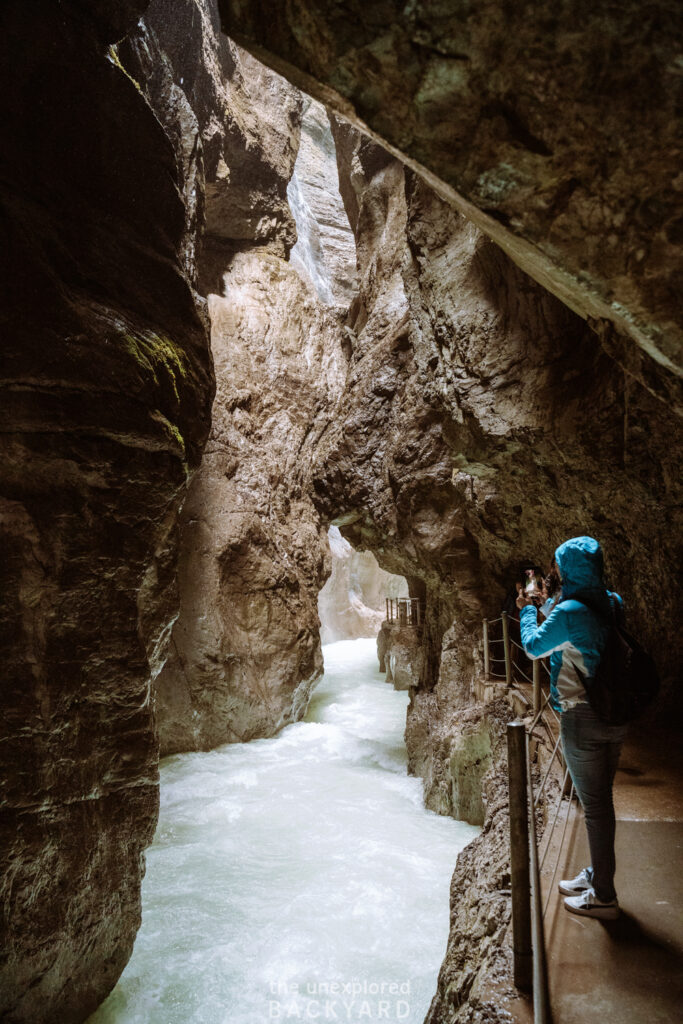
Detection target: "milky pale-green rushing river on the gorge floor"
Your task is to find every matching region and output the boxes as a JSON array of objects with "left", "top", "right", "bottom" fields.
[{"left": 90, "top": 640, "right": 478, "bottom": 1024}]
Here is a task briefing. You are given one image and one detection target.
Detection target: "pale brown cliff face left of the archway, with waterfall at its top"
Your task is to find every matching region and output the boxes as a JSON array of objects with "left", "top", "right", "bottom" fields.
[{"left": 157, "top": 92, "right": 355, "bottom": 753}]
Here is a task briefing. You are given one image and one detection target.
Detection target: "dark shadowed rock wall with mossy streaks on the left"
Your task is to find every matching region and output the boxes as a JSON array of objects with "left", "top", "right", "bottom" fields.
[{"left": 0, "top": 0, "right": 213, "bottom": 1024}]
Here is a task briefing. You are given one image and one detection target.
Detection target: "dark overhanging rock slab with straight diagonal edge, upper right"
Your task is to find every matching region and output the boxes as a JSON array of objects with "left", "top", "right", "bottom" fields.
[{"left": 219, "top": 0, "right": 683, "bottom": 402}]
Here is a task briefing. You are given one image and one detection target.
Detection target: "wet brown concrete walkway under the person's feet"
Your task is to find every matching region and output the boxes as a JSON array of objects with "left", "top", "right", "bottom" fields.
[{"left": 543, "top": 729, "right": 683, "bottom": 1024}]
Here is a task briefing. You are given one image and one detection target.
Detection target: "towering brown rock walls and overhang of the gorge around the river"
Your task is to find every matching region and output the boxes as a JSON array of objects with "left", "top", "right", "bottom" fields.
[{"left": 0, "top": 0, "right": 683, "bottom": 1024}]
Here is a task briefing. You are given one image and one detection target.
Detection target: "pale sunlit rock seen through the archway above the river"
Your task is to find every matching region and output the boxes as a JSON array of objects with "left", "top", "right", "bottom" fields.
[{"left": 317, "top": 526, "right": 408, "bottom": 643}]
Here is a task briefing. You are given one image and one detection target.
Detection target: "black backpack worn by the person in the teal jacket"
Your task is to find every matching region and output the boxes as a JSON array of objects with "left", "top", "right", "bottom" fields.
[{"left": 574, "top": 595, "right": 659, "bottom": 725}]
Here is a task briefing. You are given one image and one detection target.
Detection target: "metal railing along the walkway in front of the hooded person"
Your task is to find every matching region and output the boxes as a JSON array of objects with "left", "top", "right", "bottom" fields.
[{"left": 483, "top": 612, "right": 574, "bottom": 1024}]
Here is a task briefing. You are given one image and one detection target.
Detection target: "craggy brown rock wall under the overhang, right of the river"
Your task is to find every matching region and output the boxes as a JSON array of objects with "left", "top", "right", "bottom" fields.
[{"left": 305, "top": 121, "right": 681, "bottom": 1024}]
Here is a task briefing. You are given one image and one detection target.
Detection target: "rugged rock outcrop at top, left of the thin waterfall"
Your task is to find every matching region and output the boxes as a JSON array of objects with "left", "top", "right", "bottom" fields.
[{"left": 119, "top": 0, "right": 302, "bottom": 282}]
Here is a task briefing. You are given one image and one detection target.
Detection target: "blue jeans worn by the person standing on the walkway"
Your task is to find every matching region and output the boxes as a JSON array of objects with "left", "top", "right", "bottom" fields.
[{"left": 560, "top": 703, "right": 628, "bottom": 903}]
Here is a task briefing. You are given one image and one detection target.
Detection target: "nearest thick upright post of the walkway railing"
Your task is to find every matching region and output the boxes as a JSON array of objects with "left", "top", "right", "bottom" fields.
[{"left": 507, "top": 722, "right": 532, "bottom": 991}]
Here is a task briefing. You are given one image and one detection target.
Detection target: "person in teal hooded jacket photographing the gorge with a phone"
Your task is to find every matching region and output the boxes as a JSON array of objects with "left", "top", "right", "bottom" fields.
[{"left": 517, "top": 537, "right": 627, "bottom": 920}]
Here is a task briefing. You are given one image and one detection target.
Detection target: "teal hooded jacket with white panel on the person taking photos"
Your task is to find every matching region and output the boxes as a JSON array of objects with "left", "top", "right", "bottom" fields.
[{"left": 519, "top": 537, "right": 623, "bottom": 711}]
